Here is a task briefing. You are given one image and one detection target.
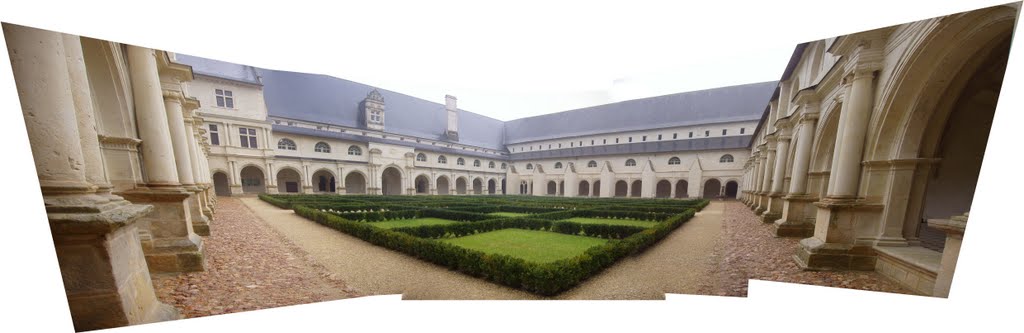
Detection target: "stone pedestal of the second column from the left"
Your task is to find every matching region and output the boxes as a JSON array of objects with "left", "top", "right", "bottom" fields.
[{"left": 122, "top": 186, "right": 206, "bottom": 273}]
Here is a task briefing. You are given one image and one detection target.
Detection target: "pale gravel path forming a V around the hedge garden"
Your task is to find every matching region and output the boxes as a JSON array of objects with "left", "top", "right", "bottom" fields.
[{"left": 241, "top": 198, "right": 725, "bottom": 299}]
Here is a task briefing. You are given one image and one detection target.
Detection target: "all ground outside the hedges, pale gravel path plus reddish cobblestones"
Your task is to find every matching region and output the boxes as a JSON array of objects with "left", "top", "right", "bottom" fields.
[{"left": 153, "top": 198, "right": 909, "bottom": 318}]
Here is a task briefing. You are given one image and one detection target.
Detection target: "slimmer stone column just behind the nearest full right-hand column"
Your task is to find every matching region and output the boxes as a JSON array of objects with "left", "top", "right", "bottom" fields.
[{"left": 775, "top": 110, "right": 817, "bottom": 238}]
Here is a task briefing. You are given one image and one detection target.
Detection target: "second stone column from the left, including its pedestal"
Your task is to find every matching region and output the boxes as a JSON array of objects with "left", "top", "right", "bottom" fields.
[{"left": 123, "top": 45, "right": 205, "bottom": 273}]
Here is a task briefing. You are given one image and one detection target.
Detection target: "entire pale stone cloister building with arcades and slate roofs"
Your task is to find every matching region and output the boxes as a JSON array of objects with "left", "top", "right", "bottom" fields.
[{"left": 3, "top": 4, "right": 1019, "bottom": 330}]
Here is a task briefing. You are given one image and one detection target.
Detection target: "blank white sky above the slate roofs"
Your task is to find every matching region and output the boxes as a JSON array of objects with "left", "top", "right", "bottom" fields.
[{"left": 0, "top": 0, "right": 1000, "bottom": 120}]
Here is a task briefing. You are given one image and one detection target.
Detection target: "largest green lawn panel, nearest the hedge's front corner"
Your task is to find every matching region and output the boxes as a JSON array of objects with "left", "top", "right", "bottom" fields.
[{"left": 440, "top": 228, "right": 607, "bottom": 262}]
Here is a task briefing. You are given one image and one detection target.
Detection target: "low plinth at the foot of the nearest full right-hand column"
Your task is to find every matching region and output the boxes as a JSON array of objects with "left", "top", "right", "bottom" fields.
[{"left": 793, "top": 237, "right": 878, "bottom": 270}]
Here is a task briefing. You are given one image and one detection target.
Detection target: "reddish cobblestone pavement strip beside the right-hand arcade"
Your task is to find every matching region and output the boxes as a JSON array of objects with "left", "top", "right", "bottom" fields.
[{"left": 698, "top": 201, "right": 913, "bottom": 296}]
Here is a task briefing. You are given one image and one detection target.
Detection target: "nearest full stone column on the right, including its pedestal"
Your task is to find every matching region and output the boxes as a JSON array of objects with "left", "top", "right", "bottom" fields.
[{"left": 795, "top": 70, "right": 878, "bottom": 270}]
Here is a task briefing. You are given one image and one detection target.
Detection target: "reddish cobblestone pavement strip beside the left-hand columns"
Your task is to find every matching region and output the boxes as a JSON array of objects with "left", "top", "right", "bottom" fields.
[{"left": 153, "top": 198, "right": 359, "bottom": 318}]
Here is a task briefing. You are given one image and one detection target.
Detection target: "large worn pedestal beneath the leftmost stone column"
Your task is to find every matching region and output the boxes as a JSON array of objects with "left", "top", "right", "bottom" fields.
[{"left": 44, "top": 191, "right": 181, "bottom": 331}]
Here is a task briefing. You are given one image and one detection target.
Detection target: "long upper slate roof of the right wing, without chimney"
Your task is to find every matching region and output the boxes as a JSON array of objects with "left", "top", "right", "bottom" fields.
[{"left": 505, "top": 81, "right": 778, "bottom": 144}]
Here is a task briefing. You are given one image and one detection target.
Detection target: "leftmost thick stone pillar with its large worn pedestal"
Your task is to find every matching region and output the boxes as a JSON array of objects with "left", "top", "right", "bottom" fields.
[{"left": 3, "top": 24, "right": 179, "bottom": 331}]
